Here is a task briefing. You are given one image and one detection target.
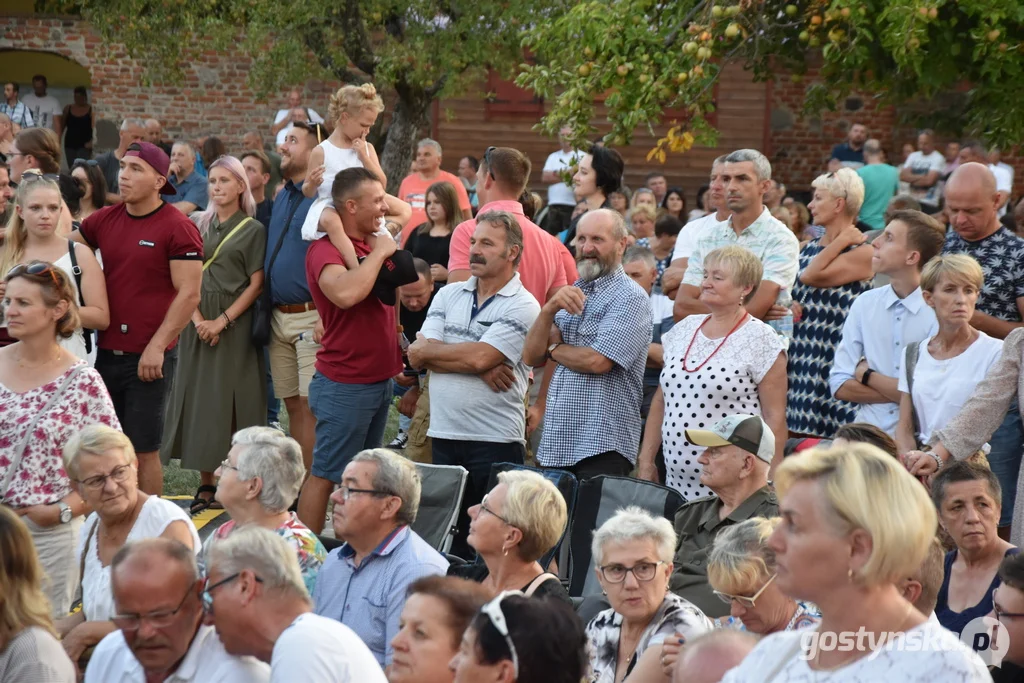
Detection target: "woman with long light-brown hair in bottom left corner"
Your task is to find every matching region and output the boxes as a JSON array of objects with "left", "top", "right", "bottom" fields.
[{"left": 0, "top": 506, "right": 77, "bottom": 683}]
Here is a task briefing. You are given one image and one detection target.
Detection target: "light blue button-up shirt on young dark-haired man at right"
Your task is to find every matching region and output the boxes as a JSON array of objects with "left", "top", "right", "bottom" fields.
[{"left": 828, "top": 285, "right": 939, "bottom": 436}]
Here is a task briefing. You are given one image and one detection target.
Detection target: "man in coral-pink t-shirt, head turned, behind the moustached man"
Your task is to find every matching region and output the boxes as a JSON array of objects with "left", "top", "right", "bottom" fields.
[{"left": 448, "top": 147, "right": 579, "bottom": 306}]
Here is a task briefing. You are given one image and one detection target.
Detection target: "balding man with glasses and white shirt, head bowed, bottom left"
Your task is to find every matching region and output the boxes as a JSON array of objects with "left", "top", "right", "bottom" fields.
[{"left": 85, "top": 539, "right": 270, "bottom": 683}]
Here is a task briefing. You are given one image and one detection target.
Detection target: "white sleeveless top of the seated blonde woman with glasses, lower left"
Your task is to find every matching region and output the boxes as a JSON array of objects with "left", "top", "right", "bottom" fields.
[{"left": 75, "top": 496, "right": 203, "bottom": 622}]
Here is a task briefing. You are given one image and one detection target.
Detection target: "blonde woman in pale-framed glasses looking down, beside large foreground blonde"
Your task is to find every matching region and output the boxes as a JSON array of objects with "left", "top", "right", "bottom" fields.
[{"left": 708, "top": 517, "right": 821, "bottom": 636}]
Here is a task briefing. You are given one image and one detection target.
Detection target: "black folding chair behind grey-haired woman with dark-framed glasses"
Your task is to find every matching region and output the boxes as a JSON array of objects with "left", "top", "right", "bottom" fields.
[{"left": 568, "top": 475, "right": 685, "bottom": 598}]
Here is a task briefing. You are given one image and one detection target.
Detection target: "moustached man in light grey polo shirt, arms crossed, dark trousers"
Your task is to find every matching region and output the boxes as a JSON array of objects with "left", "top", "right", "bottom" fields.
[{"left": 409, "top": 211, "right": 541, "bottom": 557}]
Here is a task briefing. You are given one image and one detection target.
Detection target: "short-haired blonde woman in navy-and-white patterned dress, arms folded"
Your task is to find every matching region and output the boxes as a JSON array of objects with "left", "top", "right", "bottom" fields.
[{"left": 782, "top": 168, "right": 873, "bottom": 438}]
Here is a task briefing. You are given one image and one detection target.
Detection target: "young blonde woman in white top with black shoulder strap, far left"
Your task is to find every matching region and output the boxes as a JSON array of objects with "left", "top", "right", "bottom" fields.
[{"left": 0, "top": 171, "right": 111, "bottom": 360}]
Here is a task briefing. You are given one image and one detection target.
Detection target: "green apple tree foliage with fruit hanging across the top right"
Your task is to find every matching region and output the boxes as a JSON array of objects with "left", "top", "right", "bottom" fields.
[{"left": 518, "top": 0, "right": 1024, "bottom": 154}]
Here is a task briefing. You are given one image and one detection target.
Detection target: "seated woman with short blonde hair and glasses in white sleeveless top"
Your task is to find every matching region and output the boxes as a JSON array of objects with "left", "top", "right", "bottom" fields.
[{"left": 56, "top": 425, "right": 202, "bottom": 661}]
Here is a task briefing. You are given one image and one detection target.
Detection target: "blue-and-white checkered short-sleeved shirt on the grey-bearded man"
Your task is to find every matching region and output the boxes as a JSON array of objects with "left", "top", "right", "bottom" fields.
[{"left": 538, "top": 266, "right": 652, "bottom": 467}]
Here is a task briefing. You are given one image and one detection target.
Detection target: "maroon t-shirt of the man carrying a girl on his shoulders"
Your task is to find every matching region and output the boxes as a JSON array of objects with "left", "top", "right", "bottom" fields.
[{"left": 306, "top": 238, "right": 402, "bottom": 384}]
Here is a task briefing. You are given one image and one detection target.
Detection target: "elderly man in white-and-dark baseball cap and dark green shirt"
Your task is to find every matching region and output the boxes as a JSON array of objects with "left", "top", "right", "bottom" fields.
[{"left": 669, "top": 415, "right": 778, "bottom": 618}]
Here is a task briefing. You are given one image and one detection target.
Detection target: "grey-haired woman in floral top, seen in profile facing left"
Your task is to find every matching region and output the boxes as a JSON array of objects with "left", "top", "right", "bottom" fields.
[{"left": 207, "top": 427, "right": 327, "bottom": 594}]
